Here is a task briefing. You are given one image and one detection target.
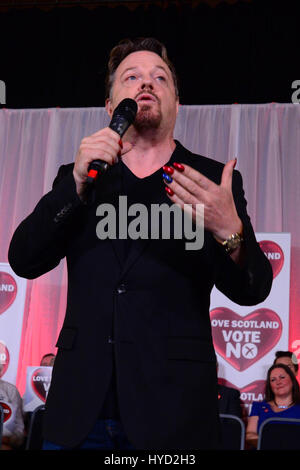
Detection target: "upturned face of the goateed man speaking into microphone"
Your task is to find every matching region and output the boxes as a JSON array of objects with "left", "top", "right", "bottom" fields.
[{"left": 106, "top": 51, "right": 178, "bottom": 130}]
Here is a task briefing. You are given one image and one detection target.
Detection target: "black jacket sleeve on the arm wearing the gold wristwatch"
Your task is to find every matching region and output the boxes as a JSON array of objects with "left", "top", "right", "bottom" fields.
[{"left": 215, "top": 171, "right": 273, "bottom": 305}]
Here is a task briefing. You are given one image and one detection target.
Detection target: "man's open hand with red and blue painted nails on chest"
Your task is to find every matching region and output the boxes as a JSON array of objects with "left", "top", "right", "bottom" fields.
[{"left": 164, "top": 160, "right": 243, "bottom": 242}]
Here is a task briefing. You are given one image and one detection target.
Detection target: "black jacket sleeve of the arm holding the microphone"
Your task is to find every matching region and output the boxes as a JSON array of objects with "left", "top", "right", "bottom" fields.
[{"left": 8, "top": 165, "right": 84, "bottom": 279}]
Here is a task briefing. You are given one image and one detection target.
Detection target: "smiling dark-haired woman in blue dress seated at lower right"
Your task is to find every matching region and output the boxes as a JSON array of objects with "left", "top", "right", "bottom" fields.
[{"left": 246, "top": 364, "right": 300, "bottom": 447}]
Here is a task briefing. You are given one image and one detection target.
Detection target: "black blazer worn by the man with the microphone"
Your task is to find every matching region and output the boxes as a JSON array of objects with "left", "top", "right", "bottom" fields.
[{"left": 9, "top": 142, "right": 272, "bottom": 449}]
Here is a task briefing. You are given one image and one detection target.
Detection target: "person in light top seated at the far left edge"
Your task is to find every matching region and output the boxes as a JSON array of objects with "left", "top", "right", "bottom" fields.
[{"left": 0, "top": 364, "right": 24, "bottom": 450}]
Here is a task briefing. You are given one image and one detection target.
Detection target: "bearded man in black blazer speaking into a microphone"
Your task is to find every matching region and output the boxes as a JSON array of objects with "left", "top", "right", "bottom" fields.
[{"left": 9, "top": 38, "right": 272, "bottom": 450}]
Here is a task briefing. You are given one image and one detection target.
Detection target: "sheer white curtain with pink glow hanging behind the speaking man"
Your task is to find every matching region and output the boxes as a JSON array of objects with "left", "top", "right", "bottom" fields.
[{"left": 0, "top": 103, "right": 300, "bottom": 393}]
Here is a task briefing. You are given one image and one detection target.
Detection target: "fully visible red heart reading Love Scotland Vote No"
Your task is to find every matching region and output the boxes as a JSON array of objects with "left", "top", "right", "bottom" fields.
[{"left": 210, "top": 307, "right": 282, "bottom": 371}]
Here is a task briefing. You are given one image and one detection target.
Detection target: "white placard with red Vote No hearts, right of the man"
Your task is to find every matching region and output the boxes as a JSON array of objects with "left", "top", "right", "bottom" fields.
[{"left": 210, "top": 233, "right": 290, "bottom": 413}]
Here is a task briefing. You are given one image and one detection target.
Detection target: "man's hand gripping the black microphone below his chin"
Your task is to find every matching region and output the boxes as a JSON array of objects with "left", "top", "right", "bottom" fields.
[{"left": 73, "top": 127, "right": 132, "bottom": 198}]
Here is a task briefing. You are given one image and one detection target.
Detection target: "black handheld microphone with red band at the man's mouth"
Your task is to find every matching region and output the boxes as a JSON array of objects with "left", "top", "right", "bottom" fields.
[{"left": 86, "top": 98, "right": 138, "bottom": 183}]
